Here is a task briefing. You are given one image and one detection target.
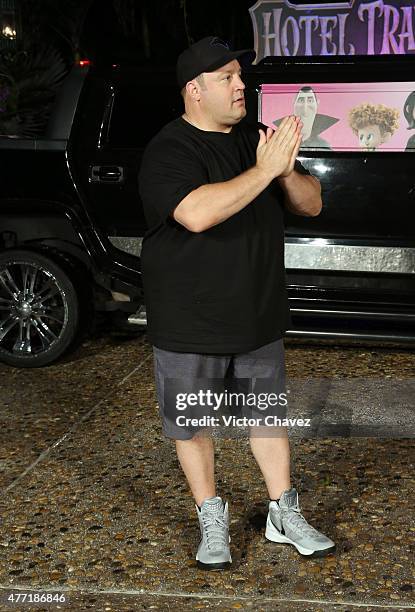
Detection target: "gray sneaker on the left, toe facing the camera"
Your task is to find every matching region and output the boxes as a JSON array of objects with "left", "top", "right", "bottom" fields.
[{"left": 196, "top": 497, "right": 232, "bottom": 570}]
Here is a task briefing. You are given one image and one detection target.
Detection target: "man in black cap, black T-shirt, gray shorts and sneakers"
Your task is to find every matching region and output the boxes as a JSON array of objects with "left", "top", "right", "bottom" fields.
[{"left": 140, "top": 36, "right": 334, "bottom": 569}]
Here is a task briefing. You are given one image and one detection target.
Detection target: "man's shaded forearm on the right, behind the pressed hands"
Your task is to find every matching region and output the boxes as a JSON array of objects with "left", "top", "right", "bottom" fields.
[{"left": 278, "top": 170, "right": 322, "bottom": 217}]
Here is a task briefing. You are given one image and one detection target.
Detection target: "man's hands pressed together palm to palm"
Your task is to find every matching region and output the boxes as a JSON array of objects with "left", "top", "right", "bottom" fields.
[{"left": 256, "top": 116, "right": 302, "bottom": 179}]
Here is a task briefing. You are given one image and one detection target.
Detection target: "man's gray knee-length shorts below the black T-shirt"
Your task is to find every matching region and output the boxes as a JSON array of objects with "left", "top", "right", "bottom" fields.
[{"left": 153, "top": 338, "right": 286, "bottom": 440}]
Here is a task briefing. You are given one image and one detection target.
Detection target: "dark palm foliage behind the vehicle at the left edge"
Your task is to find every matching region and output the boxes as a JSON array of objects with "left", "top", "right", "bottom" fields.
[{"left": 0, "top": 47, "right": 67, "bottom": 138}]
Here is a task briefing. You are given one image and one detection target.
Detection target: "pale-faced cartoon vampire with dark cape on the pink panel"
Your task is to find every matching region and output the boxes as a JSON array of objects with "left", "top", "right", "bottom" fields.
[{"left": 273, "top": 85, "right": 338, "bottom": 150}]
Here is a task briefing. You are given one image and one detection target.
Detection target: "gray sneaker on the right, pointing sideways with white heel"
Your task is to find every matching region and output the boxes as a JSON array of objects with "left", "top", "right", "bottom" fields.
[{"left": 265, "top": 489, "right": 336, "bottom": 557}]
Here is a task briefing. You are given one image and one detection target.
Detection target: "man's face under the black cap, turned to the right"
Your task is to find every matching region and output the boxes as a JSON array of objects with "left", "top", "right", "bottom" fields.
[{"left": 200, "top": 60, "right": 246, "bottom": 128}]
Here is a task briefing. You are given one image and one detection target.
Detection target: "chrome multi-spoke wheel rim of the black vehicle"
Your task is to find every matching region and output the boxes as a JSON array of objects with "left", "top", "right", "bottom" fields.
[{"left": 0, "top": 262, "right": 68, "bottom": 357}]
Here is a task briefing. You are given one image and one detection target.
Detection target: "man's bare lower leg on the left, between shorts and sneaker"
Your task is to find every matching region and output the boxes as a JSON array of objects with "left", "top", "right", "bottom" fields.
[{"left": 176, "top": 435, "right": 216, "bottom": 507}]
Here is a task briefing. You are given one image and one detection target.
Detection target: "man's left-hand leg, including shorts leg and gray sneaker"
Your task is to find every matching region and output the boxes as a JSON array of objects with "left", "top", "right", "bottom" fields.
[{"left": 154, "top": 347, "right": 232, "bottom": 570}]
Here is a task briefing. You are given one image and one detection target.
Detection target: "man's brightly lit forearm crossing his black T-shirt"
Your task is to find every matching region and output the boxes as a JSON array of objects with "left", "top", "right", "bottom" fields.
[{"left": 174, "top": 166, "right": 272, "bottom": 232}]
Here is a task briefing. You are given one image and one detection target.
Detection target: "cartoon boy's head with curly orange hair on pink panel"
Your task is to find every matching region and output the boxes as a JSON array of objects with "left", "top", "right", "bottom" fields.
[{"left": 349, "top": 102, "right": 399, "bottom": 151}]
